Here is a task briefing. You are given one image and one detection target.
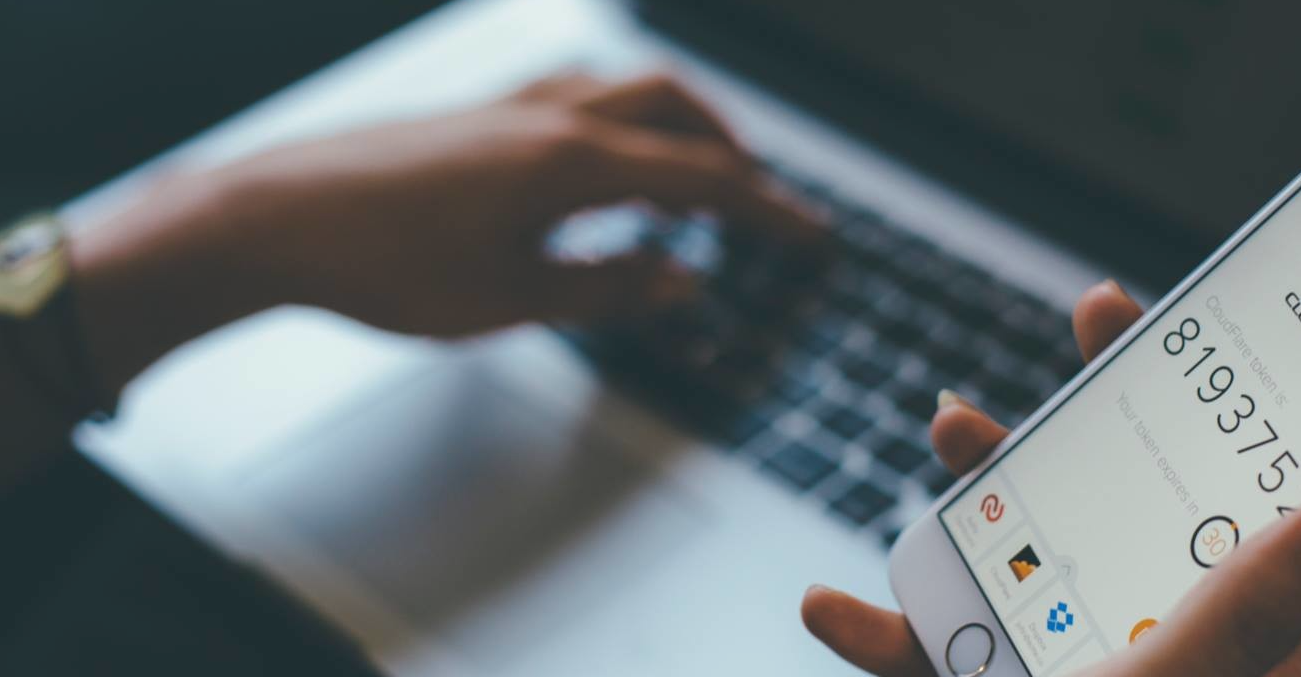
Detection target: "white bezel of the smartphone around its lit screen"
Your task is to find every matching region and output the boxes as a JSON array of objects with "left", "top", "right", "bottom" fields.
[{"left": 890, "top": 167, "right": 1301, "bottom": 677}]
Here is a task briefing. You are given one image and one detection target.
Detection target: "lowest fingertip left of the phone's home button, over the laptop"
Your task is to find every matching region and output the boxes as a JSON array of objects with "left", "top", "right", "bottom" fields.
[{"left": 800, "top": 586, "right": 935, "bottom": 677}]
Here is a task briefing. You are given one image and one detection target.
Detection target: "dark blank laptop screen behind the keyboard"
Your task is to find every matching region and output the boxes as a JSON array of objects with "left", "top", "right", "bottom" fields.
[{"left": 676, "top": 0, "right": 1301, "bottom": 240}]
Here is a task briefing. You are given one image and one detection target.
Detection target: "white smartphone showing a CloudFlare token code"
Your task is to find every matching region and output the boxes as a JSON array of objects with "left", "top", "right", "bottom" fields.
[{"left": 890, "top": 177, "right": 1301, "bottom": 677}]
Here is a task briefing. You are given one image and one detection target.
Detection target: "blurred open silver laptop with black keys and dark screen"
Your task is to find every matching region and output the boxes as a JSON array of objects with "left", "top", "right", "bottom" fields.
[{"left": 65, "top": 0, "right": 1301, "bottom": 676}]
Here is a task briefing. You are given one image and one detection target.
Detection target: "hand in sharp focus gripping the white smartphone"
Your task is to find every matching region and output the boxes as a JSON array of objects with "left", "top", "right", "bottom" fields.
[{"left": 803, "top": 277, "right": 1301, "bottom": 677}]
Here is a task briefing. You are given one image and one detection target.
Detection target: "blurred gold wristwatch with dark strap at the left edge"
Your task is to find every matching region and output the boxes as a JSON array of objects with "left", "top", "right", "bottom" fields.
[{"left": 0, "top": 214, "right": 113, "bottom": 421}]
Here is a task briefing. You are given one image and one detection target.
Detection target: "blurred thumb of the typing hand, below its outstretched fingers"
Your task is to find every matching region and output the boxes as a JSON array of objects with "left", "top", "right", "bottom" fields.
[{"left": 530, "top": 253, "right": 697, "bottom": 320}]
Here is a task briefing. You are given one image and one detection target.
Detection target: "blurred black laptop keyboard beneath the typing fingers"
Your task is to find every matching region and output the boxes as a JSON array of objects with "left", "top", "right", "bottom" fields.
[{"left": 570, "top": 165, "right": 1082, "bottom": 544}]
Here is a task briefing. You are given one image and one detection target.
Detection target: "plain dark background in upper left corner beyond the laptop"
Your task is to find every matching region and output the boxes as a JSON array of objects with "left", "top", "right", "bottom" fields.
[{"left": 0, "top": 0, "right": 444, "bottom": 220}]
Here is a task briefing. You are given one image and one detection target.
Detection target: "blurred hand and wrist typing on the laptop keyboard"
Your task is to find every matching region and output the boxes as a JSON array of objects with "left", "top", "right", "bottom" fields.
[{"left": 73, "top": 70, "right": 816, "bottom": 387}]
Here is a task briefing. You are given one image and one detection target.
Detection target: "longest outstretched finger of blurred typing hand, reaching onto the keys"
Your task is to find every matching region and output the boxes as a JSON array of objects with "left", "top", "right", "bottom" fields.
[{"left": 545, "top": 122, "right": 825, "bottom": 243}]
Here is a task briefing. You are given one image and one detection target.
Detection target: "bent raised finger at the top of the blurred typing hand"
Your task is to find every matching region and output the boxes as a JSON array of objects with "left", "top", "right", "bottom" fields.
[{"left": 580, "top": 73, "right": 742, "bottom": 152}]
